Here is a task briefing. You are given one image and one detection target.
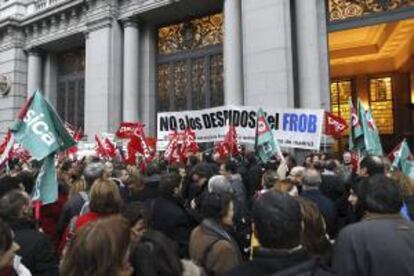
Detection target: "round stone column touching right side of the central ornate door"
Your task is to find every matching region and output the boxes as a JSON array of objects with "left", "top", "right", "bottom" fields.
[{"left": 224, "top": 0, "right": 244, "bottom": 105}]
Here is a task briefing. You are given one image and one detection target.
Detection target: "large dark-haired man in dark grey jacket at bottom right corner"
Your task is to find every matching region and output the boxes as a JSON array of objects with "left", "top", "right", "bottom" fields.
[{"left": 333, "top": 174, "right": 414, "bottom": 276}]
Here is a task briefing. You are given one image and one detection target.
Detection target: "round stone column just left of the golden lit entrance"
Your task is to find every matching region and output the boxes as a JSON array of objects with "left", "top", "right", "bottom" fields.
[{"left": 295, "top": 0, "right": 330, "bottom": 110}]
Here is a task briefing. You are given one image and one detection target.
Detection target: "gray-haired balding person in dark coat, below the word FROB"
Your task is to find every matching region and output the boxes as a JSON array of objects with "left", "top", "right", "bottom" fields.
[{"left": 301, "top": 169, "right": 337, "bottom": 238}]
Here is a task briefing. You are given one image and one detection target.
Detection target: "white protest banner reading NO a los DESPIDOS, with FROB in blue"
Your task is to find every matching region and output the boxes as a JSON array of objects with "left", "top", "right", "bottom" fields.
[{"left": 157, "top": 106, "right": 324, "bottom": 151}]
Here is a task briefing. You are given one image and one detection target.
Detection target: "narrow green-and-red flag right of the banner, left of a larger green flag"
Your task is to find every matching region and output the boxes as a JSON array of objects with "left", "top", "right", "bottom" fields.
[{"left": 349, "top": 99, "right": 364, "bottom": 151}]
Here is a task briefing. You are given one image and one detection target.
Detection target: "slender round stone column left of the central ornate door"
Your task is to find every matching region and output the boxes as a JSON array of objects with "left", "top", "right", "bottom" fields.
[{"left": 122, "top": 20, "right": 139, "bottom": 122}]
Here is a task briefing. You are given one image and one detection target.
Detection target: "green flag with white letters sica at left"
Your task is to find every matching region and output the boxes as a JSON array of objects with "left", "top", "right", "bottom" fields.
[{"left": 10, "top": 90, "right": 75, "bottom": 160}]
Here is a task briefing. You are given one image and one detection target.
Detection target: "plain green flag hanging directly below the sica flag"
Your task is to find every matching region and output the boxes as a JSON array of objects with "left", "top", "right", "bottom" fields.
[{"left": 32, "top": 153, "right": 58, "bottom": 205}]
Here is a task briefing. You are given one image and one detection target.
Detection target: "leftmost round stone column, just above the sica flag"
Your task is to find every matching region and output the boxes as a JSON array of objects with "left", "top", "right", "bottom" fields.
[{"left": 27, "top": 50, "right": 42, "bottom": 97}]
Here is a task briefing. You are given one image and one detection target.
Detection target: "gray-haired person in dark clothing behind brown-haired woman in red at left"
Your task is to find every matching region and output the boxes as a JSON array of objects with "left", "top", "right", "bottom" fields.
[{"left": 56, "top": 162, "right": 105, "bottom": 240}]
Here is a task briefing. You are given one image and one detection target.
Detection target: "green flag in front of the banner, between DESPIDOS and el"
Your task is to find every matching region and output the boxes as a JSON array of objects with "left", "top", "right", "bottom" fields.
[{"left": 256, "top": 108, "right": 280, "bottom": 163}]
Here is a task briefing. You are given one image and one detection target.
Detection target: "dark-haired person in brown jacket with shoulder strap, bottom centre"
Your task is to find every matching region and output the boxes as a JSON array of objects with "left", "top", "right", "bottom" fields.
[{"left": 189, "top": 193, "right": 242, "bottom": 275}]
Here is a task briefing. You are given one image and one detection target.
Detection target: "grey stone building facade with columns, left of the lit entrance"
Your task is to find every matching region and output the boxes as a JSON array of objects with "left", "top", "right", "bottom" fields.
[{"left": 0, "top": 0, "right": 329, "bottom": 137}]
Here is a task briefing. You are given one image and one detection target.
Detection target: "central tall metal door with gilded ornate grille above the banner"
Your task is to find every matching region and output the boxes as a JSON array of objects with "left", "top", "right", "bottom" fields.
[{"left": 157, "top": 14, "right": 224, "bottom": 111}]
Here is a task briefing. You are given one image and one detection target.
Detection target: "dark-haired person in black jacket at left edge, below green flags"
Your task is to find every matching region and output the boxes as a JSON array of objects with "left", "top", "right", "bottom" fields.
[{"left": 0, "top": 190, "right": 58, "bottom": 276}]
